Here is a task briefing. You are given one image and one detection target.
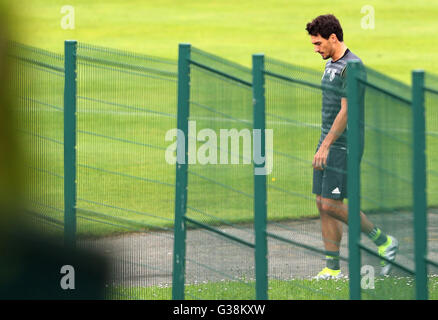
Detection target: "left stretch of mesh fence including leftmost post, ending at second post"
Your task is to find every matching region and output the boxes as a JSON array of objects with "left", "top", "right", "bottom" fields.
[{"left": 11, "top": 41, "right": 177, "bottom": 299}]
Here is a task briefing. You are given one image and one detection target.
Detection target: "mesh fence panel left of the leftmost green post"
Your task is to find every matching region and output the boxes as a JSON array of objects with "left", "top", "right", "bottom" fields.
[{"left": 9, "top": 43, "right": 64, "bottom": 239}]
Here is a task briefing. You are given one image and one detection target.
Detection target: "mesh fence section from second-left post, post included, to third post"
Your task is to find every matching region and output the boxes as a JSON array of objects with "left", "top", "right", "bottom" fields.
[{"left": 173, "top": 45, "right": 255, "bottom": 299}]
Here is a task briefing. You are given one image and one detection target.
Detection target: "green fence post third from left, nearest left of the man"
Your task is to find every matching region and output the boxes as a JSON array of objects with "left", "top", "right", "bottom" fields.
[{"left": 252, "top": 54, "right": 268, "bottom": 300}]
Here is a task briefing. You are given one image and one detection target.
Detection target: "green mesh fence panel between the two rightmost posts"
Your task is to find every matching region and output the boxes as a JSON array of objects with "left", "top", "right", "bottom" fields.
[{"left": 359, "top": 68, "right": 415, "bottom": 299}]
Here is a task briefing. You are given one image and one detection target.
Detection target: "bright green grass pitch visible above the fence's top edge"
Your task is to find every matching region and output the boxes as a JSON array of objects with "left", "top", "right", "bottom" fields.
[{"left": 12, "top": 0, "right": 438, "bottom": 82}]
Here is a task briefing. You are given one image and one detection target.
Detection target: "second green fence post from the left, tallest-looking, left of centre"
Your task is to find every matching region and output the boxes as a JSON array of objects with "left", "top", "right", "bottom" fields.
[{"left": 172, "top": 44, "right": 191, "bottom": 300}]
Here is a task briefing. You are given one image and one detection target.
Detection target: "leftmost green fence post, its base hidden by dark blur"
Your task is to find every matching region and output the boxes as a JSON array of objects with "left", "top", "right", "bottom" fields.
[{"left": 64, "top": 40, "right": 77, "bottom": 248}]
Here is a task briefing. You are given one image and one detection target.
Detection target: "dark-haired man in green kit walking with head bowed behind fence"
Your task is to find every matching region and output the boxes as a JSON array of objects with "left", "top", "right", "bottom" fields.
[{"left": 306, "top": 14, "right": 398, "bottom": 279}]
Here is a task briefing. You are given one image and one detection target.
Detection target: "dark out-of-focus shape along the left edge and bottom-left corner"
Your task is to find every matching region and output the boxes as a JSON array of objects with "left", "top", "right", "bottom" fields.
[{"left": 0, "top": 1, "right": 107, "bottom": 299}]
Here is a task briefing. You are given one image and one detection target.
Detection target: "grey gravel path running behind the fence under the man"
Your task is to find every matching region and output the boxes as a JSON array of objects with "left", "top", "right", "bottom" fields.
[{"left": 80, "top": 213, "right": 438, "bottom": 286}]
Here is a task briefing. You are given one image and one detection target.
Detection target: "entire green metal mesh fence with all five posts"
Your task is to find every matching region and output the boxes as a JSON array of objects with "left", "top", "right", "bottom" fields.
[{"left": 11, "top": 41, "right": 438, "bottom": 299}]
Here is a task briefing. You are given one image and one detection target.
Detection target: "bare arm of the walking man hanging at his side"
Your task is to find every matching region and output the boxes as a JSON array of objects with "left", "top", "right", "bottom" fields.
[{"left": 312, "top": 98, "right": 347, "bottom": 170}]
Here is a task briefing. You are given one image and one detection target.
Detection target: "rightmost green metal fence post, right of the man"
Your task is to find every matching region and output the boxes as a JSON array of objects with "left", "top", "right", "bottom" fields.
[{"left": 412, "top": 70, "right": 428, "bottom": 300}]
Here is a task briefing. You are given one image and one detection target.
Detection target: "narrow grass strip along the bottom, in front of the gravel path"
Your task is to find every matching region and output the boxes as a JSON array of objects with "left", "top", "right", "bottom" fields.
[{"left": 109, "top": 277, "right": 438, "bottom": 300}]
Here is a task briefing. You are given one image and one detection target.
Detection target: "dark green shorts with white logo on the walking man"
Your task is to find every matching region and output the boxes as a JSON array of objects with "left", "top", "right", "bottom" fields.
[{"left": 312, "top": 147, "right": 347, "bottom": 200}]
